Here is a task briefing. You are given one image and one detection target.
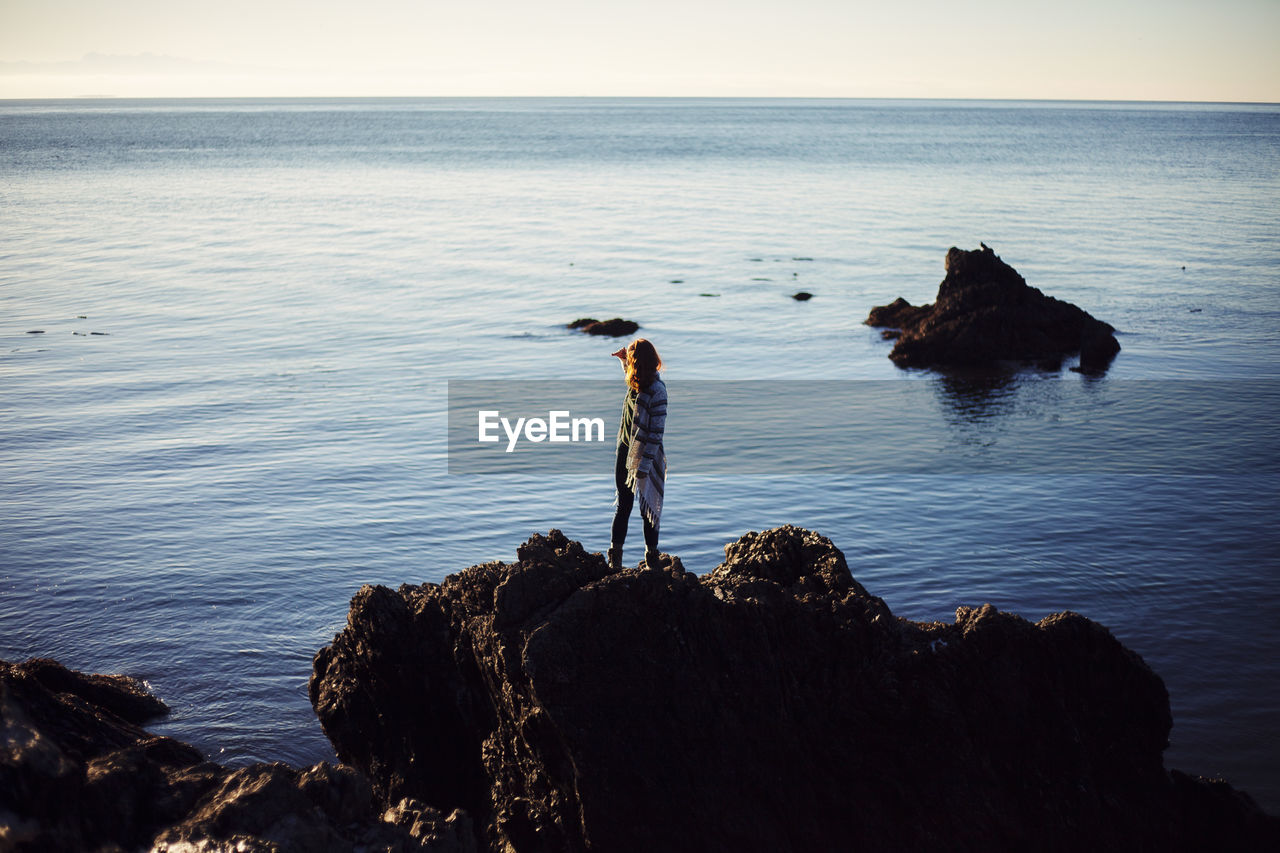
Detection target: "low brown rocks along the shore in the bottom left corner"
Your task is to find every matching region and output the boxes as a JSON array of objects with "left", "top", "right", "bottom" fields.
[{"left": 0, "top": 660, "right": 475, "bottom": 853}]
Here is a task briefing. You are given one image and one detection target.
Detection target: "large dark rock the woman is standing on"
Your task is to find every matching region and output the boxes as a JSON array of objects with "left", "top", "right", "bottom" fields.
[{"left": 310, "top": 526, "right": 1280, "bottom": 853}]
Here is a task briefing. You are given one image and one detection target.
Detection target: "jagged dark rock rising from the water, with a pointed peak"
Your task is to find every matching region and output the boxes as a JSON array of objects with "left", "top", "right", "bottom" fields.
[{"left": 867, "top": 245, "right": 1120, "bottom": 371}]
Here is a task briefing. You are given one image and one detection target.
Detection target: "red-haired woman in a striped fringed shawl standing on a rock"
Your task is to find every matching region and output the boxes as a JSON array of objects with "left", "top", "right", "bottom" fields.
[{"left": 609, "top": 338, "right": 667, "bottom": 569}]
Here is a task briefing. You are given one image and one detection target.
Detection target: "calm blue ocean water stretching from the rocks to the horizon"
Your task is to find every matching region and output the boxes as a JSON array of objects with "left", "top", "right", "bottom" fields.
[{"left": 0, "top": 100, "right": 1280, "bottom": 811}]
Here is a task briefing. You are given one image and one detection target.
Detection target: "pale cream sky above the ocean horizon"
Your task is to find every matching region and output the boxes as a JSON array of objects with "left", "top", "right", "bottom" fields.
[{"left": 0, "top": 0, "right": 1280, "bottom": 102}]
